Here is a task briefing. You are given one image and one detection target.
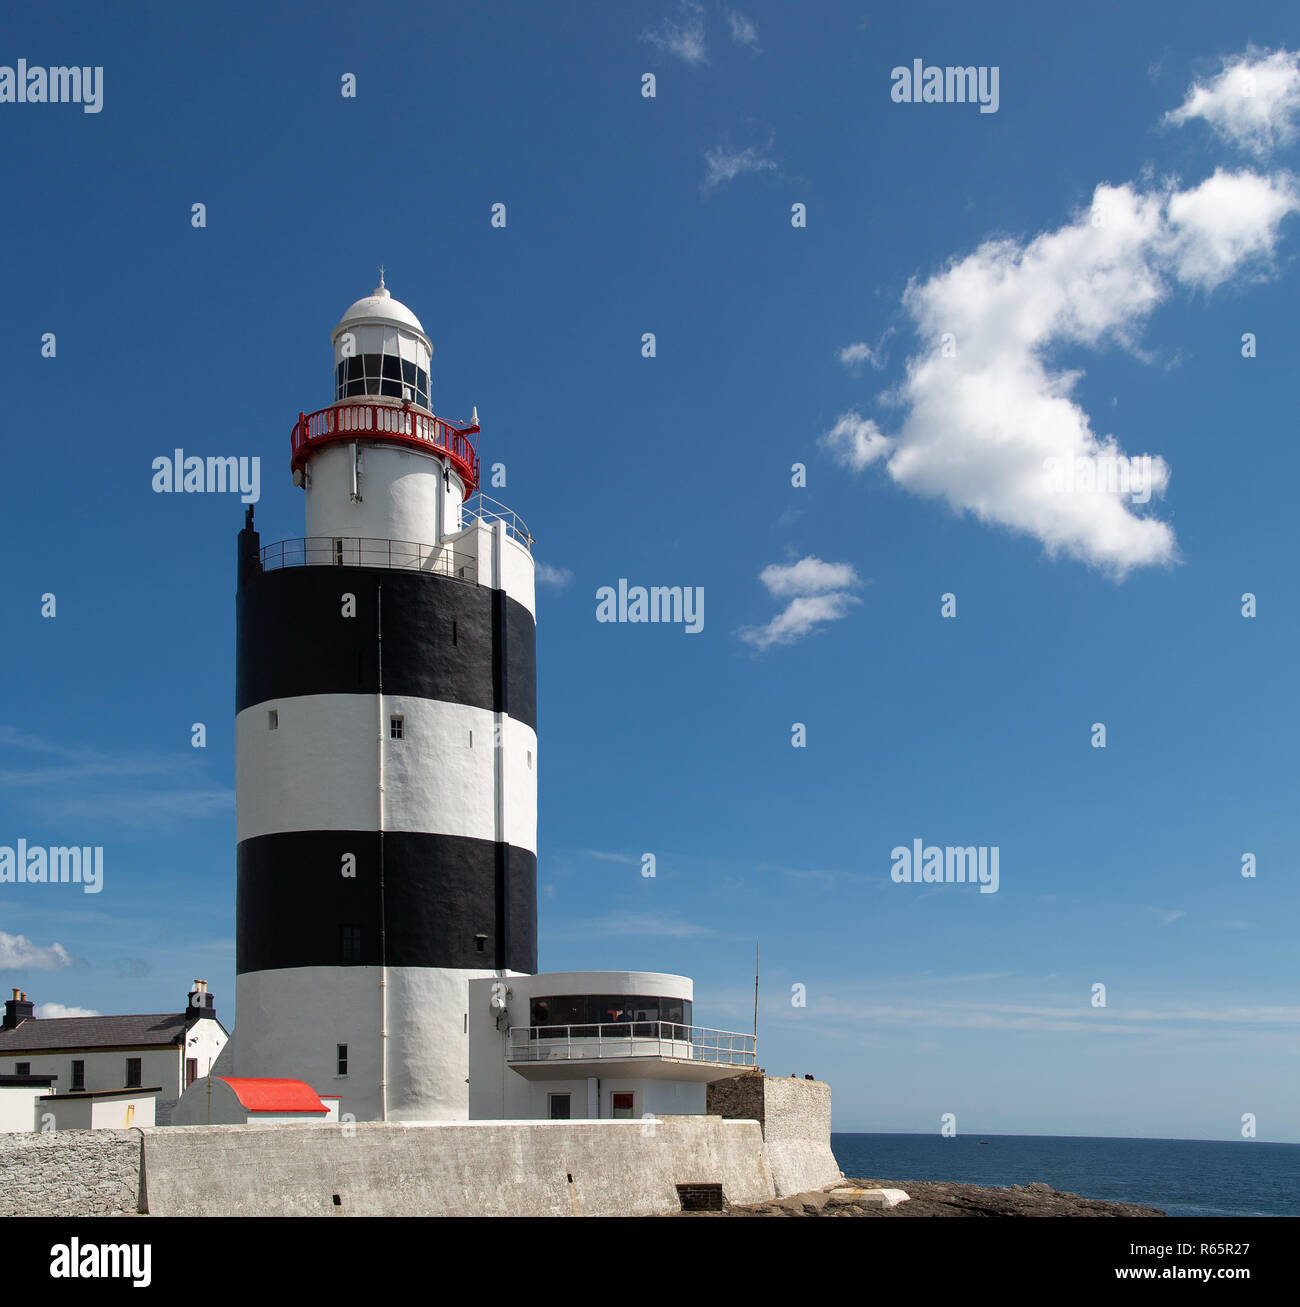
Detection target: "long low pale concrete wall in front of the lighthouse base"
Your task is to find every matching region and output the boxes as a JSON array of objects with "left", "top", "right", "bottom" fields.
[{"left": 139, "top": 1116, "right": 772, "bottom": 1217}]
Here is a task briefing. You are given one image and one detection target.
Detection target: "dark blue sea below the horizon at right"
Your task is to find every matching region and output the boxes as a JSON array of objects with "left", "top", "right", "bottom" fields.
[{"left": 831, "top": 1134, "right": 1300, "bottom": 1217}]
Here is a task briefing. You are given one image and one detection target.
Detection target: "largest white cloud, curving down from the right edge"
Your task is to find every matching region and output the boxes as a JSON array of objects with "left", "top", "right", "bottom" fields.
[{"left": 821, "top": 170, "right": 1300, "bottom": 578}]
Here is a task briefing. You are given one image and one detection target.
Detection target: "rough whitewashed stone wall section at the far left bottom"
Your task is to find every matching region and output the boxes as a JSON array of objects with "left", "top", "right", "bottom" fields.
[{"left": 0, "top": 1129, "right": 141, "bottom": 1217}]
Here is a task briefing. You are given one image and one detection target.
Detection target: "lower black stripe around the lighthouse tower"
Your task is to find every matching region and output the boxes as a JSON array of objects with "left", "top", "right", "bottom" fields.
[{"left": 235, "top": 831, "right": 537, "bottom": 975}]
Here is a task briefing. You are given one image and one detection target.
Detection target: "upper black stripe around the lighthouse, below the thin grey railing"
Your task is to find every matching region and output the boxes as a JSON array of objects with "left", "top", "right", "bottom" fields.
[{"left": 235, "top": 567, "right": 537, "bottom": 731}]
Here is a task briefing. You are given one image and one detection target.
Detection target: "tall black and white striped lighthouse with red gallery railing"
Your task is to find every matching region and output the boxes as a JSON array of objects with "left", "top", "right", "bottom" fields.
[{"left": 216, "top": 278, "right": 537, "bottom": 1121}]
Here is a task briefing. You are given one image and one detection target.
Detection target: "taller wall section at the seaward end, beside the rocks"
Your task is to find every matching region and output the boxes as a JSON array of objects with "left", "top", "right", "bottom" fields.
[{"left": 708, "top": 1073, "right": 843, "bottom": 1197}]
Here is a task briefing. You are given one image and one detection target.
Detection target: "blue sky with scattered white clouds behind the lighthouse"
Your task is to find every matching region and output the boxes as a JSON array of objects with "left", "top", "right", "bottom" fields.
[{"left": 0, "top": 0, "right": 1300, "bottom": 1141}]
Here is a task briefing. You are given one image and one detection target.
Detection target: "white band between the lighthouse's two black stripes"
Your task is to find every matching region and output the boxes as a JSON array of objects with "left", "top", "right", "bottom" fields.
[{"left": 235, "top": 694, "right": 538, "bottom": 852}]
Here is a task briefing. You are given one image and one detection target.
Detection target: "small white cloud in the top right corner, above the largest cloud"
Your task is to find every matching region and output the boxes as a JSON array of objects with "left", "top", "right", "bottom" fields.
[{"left": 1164, "top": 46, "right": 1300, "bottom": 158}]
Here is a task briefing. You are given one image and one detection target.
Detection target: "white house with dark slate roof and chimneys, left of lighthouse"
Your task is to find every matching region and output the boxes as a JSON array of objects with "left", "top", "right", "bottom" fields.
[{"left": 0, "top": 980, "right": 227, "bottom": 1129}]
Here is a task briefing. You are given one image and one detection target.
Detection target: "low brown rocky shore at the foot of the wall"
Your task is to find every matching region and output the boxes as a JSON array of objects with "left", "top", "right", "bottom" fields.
[{"left": 682, "top": 1180, "right": 1164, "bottom": 1217}]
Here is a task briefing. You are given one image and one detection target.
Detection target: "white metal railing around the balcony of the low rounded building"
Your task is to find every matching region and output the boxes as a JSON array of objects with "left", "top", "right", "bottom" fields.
[{"left": 507, "top": 1021, "right": 756, "bottom": 1067}]
